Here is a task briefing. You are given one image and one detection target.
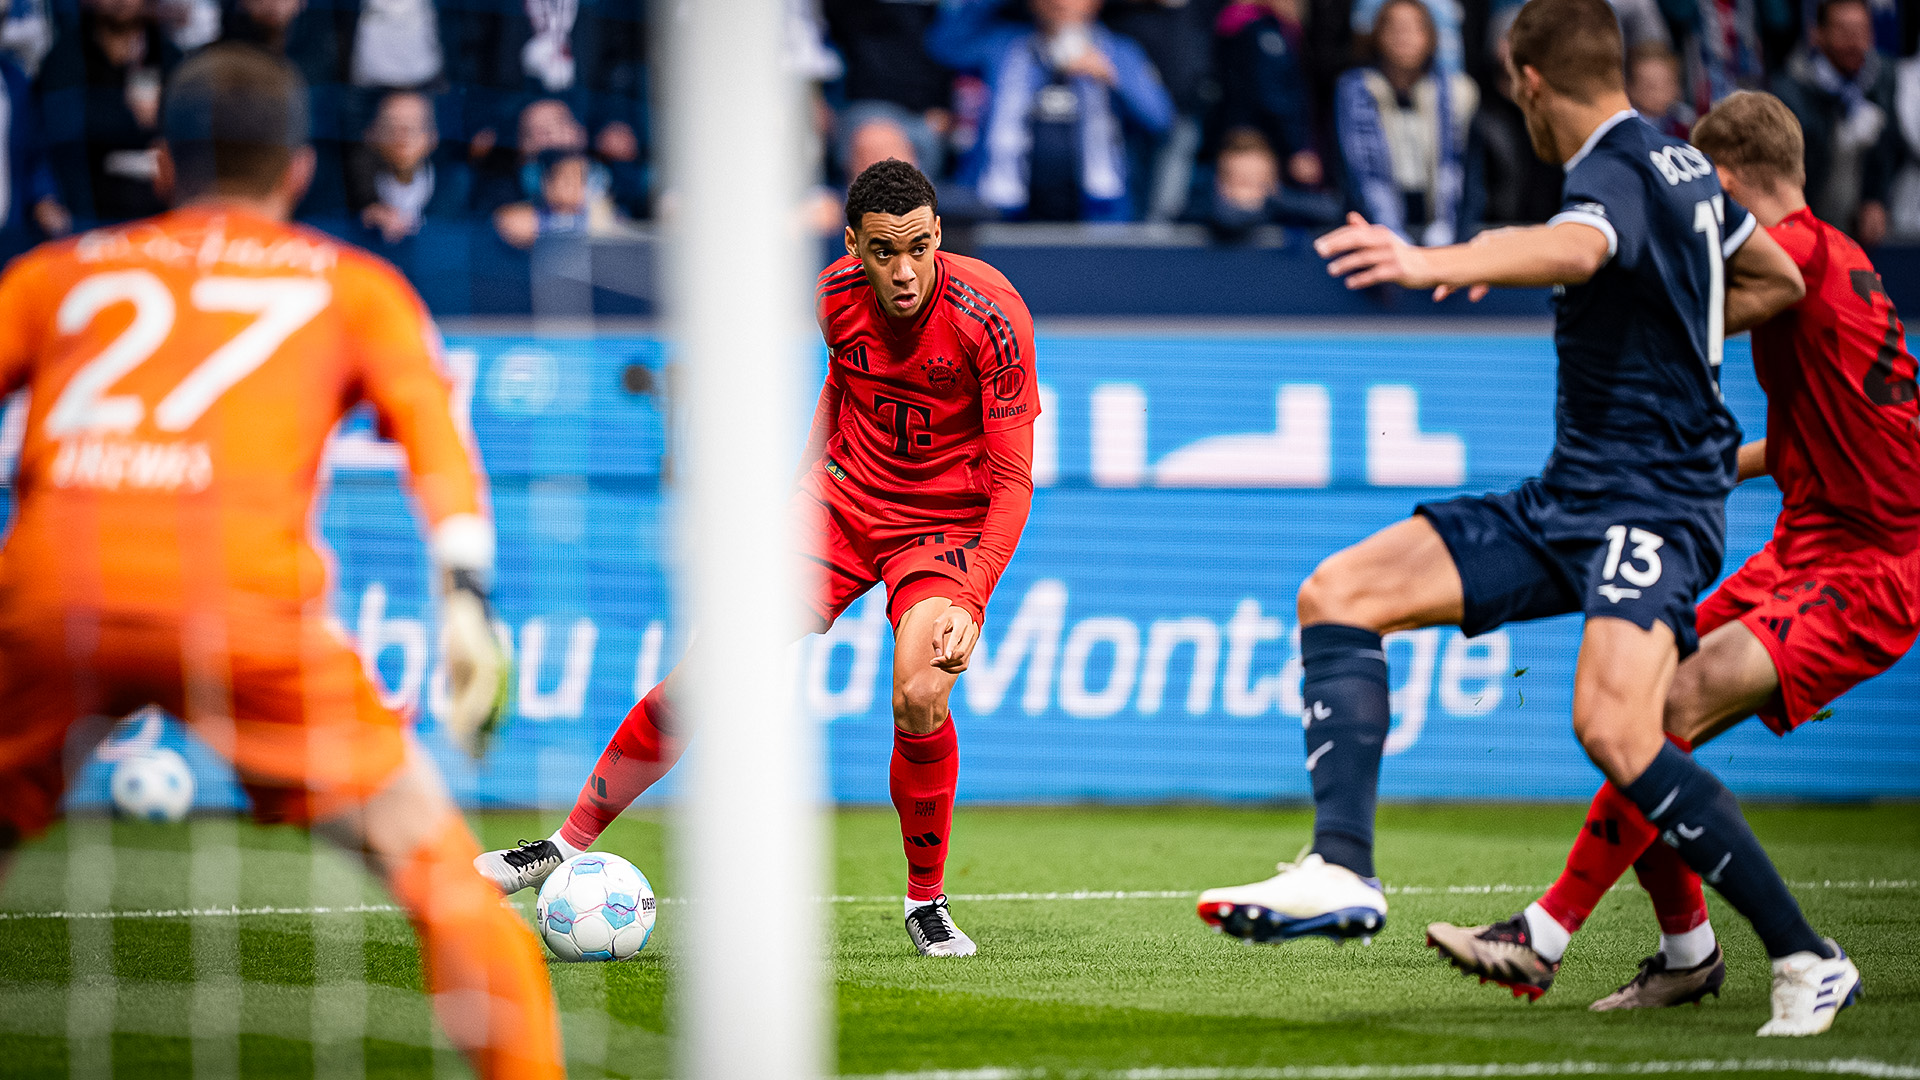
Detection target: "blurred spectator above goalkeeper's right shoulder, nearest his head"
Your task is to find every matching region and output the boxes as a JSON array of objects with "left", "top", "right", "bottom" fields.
[{"left": 348, "top": 90, "right": 468, "bottom": 244}]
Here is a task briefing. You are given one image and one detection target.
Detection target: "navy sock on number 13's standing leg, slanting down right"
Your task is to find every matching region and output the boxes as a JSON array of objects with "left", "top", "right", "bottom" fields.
[{"left": 1626, "top": 742, "right": 1830, "bottom": 959}]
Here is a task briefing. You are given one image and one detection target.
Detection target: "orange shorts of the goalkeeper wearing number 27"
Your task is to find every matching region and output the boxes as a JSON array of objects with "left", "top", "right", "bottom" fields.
[{"left": 0, "top": 605, "right": 407, "bottom": 840}]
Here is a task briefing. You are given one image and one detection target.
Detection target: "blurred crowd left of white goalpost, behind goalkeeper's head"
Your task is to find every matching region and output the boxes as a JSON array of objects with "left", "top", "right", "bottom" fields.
[{"left": 0, "top": 0, "right": 651, "bottom": 259}]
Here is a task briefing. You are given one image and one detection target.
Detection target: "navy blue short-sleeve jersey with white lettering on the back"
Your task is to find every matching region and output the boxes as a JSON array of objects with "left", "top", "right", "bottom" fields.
[{"left": 1542, "top": 111, "right": 1755, "bottom": 503}]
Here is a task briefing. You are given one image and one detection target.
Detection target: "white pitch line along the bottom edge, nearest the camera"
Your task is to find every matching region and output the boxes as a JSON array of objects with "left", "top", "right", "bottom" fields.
[{"left": 843, "top": 1057, "right": 1920, "bottom": 1080}]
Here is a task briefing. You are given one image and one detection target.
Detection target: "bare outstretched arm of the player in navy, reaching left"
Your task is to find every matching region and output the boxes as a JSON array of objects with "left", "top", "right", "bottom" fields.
[{"left": 1313, "top": 213, "right": 1609, "bottom": 300}]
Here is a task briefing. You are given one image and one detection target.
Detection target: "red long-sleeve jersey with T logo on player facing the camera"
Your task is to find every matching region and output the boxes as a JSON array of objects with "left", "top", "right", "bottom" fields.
[{"left": 808, "top": 252, "right": 1041, "bottom": 619}]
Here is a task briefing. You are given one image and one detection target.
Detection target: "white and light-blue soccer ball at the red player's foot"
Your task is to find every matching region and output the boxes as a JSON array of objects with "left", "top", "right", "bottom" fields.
[{"left": 534, "top": 851, "right": 653, "bottom": 963}]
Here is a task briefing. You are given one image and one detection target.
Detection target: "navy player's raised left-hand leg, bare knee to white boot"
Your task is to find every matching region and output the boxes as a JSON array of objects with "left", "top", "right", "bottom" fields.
[{"left": 1196, "top": 517, "right": 1463, "bottom": 942}]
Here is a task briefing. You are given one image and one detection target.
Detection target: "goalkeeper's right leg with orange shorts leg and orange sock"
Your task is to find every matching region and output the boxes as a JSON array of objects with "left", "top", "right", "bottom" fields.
[{"left": 220, "top": 619, "right": 563, "bottom": 1078}]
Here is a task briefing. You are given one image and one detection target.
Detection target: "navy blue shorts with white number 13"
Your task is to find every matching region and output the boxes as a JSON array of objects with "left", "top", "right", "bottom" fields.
[{"left": 1413, "top": 479, "right": 1726, "bottom": 657}]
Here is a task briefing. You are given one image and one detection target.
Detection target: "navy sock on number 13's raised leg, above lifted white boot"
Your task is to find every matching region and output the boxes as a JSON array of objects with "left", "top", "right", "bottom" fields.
[{"left": 1300, "top": 625, "right": 1392, "bottom": 878}]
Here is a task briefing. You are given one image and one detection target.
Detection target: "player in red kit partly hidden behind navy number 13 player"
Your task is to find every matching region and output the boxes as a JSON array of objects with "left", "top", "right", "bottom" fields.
[{"left": 1428, "top": 92, "right": 1920, "bottom": 1034}]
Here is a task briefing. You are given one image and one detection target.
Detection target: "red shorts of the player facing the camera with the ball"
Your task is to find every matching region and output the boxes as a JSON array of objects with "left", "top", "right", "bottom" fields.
[{"left": 793, "top": 469, "right": 985, "bottom": 626}]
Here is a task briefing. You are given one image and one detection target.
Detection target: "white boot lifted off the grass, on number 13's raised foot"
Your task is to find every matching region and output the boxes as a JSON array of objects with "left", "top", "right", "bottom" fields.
[{"left": 1196, "top": 855, "right": 1386, "bottom": 942}]
